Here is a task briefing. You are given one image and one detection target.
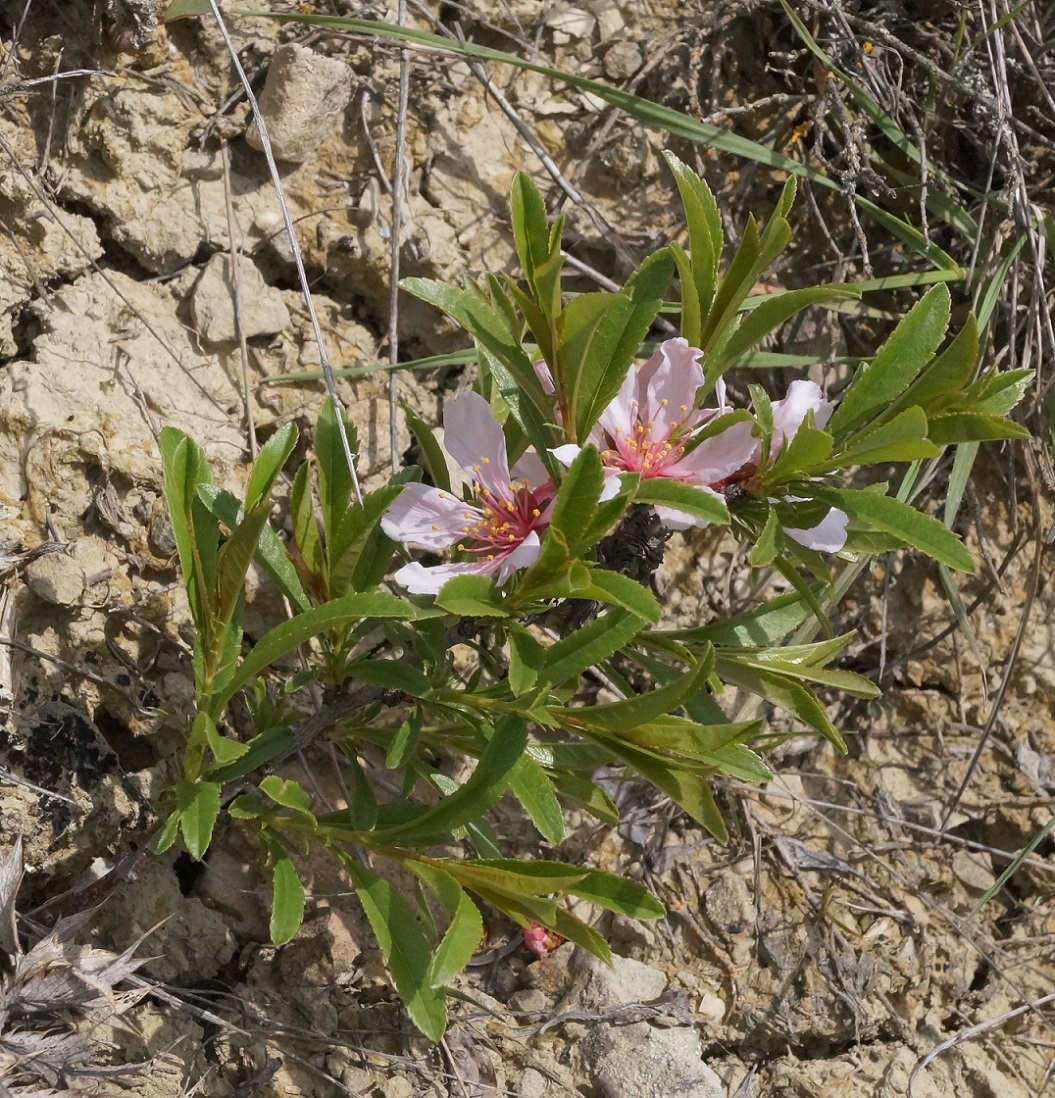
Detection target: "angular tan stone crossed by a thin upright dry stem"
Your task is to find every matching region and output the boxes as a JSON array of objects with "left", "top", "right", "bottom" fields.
[{"left": 191, "top": 253, "right": 290, "bottom": 344}]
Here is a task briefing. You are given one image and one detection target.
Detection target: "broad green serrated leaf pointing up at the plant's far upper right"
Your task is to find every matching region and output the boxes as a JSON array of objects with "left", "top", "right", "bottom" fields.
[{"left": 828, "top": 282, "right": 950, "bottom": 441}]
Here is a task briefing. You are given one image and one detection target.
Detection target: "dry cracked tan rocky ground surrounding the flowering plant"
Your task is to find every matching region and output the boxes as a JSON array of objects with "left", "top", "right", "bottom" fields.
[{"left": 0, "top": 0, "right": 1055, "bottom": 1098}]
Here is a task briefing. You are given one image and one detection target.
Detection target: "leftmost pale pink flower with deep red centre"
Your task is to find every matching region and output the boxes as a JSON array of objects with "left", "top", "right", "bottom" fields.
[{"left": 381, "top": 393, "right": 553, "bottom": 595}]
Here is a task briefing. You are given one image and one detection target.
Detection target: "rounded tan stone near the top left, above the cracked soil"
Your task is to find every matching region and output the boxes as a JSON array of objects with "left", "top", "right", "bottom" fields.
[{"left": 246, "top": 43, "right": 355, "bottom": 164}]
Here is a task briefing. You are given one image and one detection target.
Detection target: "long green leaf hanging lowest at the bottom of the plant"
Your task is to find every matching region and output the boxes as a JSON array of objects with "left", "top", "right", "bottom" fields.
[{"left": 335, "top": 850, "right": 447, "bottom": 1041}]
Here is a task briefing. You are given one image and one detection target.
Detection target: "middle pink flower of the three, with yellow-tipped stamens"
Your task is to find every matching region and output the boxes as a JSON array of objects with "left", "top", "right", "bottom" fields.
[{"left": 553, "top": 339, "right": 756, "bottom": 529}]
